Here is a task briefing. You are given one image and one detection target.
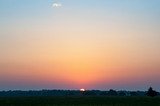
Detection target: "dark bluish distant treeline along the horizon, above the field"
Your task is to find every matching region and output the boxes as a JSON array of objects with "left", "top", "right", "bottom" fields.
[{"left": 0, "top": 87, "right": 160, "bottom": 97}]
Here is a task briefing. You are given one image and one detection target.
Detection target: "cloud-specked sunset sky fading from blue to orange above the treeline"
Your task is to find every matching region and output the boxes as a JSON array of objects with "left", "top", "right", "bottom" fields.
[{"left": 0, "top": 0, "right": 160, "bottom": 91}]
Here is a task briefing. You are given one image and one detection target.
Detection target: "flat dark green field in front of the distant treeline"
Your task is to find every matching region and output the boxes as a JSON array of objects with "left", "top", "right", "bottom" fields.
[{"left": 0, "top": 96, "right": 160, "bottom": 106}]
